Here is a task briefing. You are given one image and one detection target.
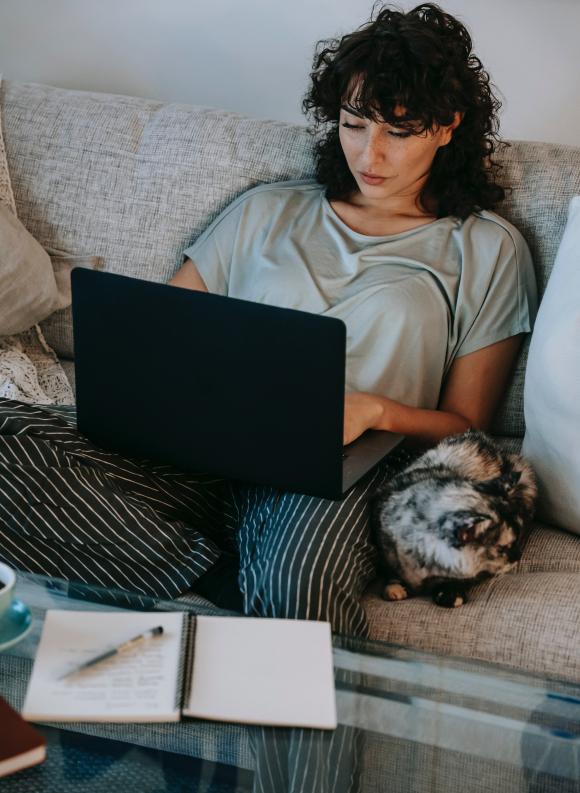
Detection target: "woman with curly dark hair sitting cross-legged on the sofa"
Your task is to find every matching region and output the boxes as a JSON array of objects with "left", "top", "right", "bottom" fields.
[{"left": 0, "top": 5, "right": 536, "bottom": 635}]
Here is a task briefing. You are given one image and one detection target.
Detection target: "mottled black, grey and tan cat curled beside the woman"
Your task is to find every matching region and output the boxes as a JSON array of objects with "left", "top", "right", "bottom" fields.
[{"left": 370, "top": 429, "right": 537, "bottom": 608}]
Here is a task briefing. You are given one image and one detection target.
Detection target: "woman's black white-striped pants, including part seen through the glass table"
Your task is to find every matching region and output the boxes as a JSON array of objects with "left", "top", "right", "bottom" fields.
[{"left": 0, "top": 399, "right": 411, "bottom": 793}]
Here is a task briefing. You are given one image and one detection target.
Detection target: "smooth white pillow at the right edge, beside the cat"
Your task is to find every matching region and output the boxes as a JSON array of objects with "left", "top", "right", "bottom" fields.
[{"left": 522, "top": 196, "right": 580, "bottom": 534}]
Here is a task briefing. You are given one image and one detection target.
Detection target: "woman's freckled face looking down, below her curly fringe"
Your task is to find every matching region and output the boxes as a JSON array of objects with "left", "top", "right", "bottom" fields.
[{"left": 339, "top": 106, "right": 459, "bottom": 210}]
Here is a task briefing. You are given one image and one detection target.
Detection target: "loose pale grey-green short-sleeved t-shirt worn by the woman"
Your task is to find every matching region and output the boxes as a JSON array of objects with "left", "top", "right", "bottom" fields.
[{"left": 184, "top": 180, "right": 537, "bottom": 409}]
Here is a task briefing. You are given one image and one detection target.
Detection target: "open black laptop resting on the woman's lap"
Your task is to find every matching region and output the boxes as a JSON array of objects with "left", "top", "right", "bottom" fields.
[{"left": 71, "top": 267, "right": 403, "bottom": 499}]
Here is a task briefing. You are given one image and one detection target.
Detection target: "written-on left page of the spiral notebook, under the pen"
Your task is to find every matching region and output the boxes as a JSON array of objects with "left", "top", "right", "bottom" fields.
[{"left": 22, "top": 610, "right": 186, "bottom": 722}]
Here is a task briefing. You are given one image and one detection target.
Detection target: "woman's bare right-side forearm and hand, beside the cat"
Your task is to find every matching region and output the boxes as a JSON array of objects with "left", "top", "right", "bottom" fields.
[{"left": 344, "top": 333, "right": 524, "bottom": 445}]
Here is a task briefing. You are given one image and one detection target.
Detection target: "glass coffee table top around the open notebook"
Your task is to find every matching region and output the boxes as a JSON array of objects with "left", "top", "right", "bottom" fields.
[{"left": 0, "top": 573, "right": 580, "bottom": 793}]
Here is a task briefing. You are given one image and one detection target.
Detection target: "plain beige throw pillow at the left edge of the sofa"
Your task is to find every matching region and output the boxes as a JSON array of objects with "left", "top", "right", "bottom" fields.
[{"left": 0, "top": 204, "right": 70, "bottom": 336}]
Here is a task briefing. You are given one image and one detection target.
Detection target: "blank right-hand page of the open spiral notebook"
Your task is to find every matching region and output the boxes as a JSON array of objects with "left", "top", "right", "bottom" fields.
[{"left": 183, "top": 617, "right": 336, "bottom": 729}]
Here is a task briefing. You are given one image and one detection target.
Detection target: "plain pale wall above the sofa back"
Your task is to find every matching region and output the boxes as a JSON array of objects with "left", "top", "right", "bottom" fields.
[{"left": 0, "top": 0, "right": 580, "bottom": 145}]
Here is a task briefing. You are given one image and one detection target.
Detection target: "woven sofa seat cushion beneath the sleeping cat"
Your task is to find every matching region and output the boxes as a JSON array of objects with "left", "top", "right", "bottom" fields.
[{"left": 364, "top": 524, "right": 580, "bottom": 681}]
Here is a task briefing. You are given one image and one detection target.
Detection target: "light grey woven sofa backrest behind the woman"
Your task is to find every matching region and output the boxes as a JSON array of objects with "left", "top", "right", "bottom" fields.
[{"left": 0, "top": 81, "right": 580, "bottom": 436}]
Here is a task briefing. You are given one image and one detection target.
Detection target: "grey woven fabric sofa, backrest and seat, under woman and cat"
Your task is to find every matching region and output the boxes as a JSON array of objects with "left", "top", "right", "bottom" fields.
[{"left": 0, "top": 82, "right": 580, "bottom": 680}]
